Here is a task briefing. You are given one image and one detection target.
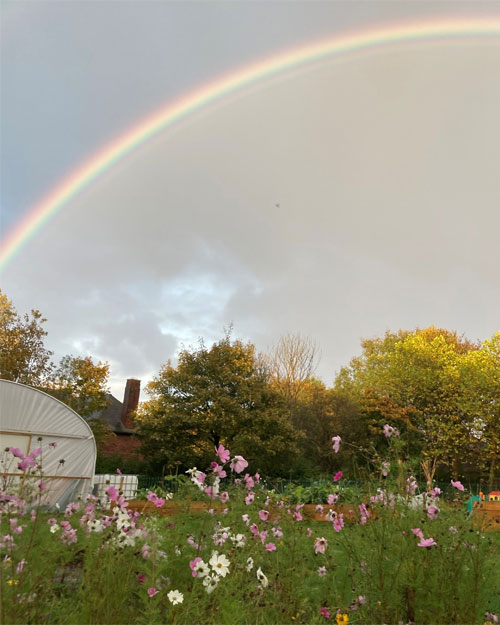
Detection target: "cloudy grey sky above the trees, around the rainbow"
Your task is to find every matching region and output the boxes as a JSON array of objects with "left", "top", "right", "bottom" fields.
[{"left": 0, "top": 0, "right": 500, "bottom": 399}]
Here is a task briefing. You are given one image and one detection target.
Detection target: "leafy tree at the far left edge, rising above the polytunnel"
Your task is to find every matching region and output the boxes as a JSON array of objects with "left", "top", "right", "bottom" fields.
[{"left": 0, "top": 291, "right": 52, "bottom": 386}]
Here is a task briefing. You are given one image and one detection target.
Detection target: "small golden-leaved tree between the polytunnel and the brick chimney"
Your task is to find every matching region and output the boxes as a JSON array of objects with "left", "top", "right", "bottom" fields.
[{"left": 45, "top": 356, "right": 109, "bottom": 417}]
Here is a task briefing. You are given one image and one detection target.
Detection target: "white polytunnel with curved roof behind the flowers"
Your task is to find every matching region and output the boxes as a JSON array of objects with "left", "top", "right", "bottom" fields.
[{"left": 0, "top": 380, "right": 97, "bottom": 507}]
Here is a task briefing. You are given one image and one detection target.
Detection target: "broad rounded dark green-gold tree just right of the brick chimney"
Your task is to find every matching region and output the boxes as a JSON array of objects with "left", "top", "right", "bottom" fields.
[{"left": 136, "top": 333, "right": 298, "bottom": 471}]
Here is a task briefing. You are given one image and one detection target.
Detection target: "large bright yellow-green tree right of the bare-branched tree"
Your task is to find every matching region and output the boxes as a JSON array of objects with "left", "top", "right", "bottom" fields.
[{"left": 336, "top": 326, "right": 479, "bottom": 476}]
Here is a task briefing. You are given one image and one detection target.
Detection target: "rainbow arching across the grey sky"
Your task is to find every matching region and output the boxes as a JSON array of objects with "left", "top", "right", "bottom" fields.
[{"left": 0, "top": 16, "right": 500, "bottom": 271}]
